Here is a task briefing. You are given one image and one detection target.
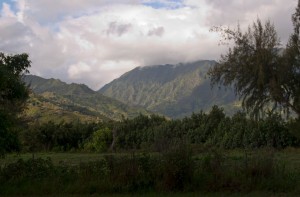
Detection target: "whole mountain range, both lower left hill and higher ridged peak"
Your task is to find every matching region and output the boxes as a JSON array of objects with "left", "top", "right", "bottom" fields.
[{"left": 24, "top": 60, "right": 240, "bottom": 120}]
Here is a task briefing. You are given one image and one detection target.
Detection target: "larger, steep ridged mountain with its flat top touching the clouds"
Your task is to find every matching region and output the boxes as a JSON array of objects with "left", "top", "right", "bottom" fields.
[{"left": 99, "top": 60, "right": 239, "bottom": 118}]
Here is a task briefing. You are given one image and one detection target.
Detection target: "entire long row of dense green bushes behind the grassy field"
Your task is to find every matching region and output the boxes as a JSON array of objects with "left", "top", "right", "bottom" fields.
[{"left": 22, "top": 106, "right": 300, "bottom": 152}]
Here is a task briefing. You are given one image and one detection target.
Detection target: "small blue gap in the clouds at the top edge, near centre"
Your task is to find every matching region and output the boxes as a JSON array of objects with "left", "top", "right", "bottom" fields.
[{"left": 143, "top": 0, "right": 185, "bottom": 9}]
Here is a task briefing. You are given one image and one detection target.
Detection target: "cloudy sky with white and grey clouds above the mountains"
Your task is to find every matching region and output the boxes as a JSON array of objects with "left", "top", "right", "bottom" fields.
[{"left": 0, "top": 0, "right": 298, "bottom": 90}]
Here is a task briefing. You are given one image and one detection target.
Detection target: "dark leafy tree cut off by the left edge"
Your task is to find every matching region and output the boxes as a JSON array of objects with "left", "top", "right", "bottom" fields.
[{"left": 0, "top": 53, "right": 31, "bottom": 155}]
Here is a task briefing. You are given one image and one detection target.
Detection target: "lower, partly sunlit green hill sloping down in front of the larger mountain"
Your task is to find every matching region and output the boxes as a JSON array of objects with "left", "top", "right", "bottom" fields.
[{"left": 23, "top": 75, "right": 149, "bottom": 122}]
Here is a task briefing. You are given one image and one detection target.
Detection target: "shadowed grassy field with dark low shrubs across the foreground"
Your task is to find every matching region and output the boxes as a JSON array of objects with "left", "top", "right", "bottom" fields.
[{"left": 0, "top": 148, "right": 300, "bottom": 196}]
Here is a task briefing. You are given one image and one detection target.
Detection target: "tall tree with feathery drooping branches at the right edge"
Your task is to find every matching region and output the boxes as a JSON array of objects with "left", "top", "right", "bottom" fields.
[{"left": 208, "top": 1, "right": 300, "bottom": 117}]
